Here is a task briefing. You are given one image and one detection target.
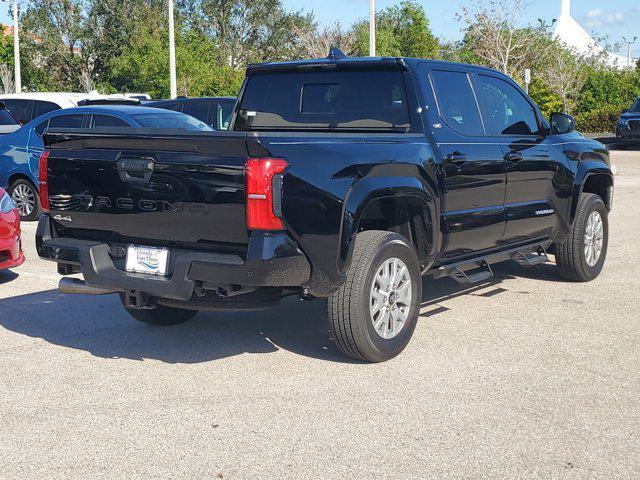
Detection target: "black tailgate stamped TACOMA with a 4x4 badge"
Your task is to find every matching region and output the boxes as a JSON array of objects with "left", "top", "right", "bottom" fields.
[{"left": 45, "top": 130, "right": 248, "bottom": 247}]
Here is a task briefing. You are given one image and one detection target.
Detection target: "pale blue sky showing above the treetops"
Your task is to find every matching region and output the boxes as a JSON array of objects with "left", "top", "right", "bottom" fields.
[{"left": 0, "top": 0, "right": 640, "bottom": 57}]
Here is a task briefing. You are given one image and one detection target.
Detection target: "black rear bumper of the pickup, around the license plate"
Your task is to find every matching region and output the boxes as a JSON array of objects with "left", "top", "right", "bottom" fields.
[{"left": 36, "top": 215, "right": 311, "bottom": 300}]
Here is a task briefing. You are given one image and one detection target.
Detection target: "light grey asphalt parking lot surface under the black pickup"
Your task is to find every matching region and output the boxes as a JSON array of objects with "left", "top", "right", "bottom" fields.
[{"left": 0, "top": 152, "right": 640, "bottom": 480}]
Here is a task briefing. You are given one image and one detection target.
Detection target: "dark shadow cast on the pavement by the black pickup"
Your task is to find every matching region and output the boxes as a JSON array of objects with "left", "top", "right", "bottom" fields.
[{"left": 0, "top": 264, "right": 557, "bottom": 364}]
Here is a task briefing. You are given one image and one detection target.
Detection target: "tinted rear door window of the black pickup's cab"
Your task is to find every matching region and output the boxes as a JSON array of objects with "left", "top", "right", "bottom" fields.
[{"left": 431, "top": 70, "right": 484, "bottom": 136}]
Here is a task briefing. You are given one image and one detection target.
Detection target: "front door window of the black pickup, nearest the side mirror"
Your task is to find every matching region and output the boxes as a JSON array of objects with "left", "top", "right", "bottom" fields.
[{"left": 477, "top": 75, "right": 540, "bottom": 135}]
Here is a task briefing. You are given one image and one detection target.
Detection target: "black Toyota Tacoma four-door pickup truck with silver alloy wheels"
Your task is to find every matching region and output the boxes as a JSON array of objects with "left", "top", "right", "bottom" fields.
[{"left": 36, "top": 50, "right": 613, "bottom": 362}]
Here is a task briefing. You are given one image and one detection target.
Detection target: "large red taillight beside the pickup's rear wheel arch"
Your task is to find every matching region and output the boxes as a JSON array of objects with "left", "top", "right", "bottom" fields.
[{"left": 246, "top": 158, "right": 288, "bottom": 230}]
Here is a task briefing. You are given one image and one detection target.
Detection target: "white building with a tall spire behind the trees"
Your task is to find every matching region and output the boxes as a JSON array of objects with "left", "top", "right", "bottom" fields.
[{"left": 553, "top": 0, "right": 627, "bottom": 69}]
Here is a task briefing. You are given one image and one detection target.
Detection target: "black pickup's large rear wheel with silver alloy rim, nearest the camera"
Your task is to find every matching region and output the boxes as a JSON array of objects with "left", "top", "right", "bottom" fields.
[{"left": 327, "top": 230, "right": 422, "bottom": 362}]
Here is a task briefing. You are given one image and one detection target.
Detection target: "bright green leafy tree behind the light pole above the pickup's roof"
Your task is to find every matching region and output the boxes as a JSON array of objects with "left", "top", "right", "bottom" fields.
[{"left": 354, "top": 1, "right": 440, "bottom": 58}]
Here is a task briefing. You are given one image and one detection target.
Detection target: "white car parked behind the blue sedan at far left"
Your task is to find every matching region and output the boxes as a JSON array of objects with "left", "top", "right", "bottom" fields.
[{"left": 0, "top": 92, "right": 149, "bottom": 125}]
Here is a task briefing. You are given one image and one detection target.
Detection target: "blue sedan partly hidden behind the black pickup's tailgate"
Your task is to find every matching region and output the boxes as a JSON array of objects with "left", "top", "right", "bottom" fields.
[{"left": 0, "top": 105, "right": 212, "bottom": 221}]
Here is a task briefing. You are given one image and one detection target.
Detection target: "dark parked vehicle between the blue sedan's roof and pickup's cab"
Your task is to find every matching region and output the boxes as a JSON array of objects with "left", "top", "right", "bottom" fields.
[{"left": 144, "top": 97, "right": 236, "bottom": 130}]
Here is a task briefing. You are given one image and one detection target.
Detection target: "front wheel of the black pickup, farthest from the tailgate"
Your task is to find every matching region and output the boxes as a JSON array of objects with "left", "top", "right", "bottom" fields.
[{"left": 556, "top": 193, "right": 609, "bottom": 282}]
